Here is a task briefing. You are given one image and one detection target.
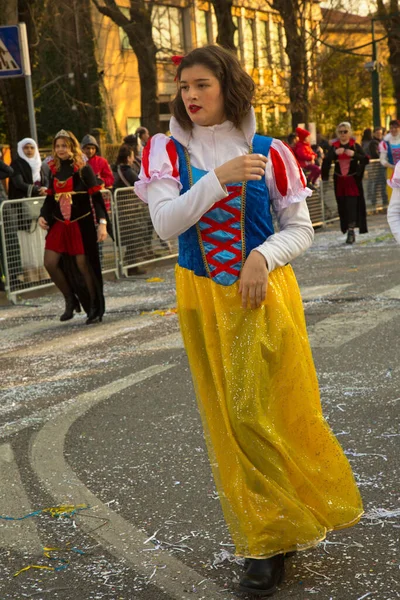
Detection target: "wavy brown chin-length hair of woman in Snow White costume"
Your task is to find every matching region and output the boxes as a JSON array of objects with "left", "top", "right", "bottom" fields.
[{"left": 171, "top": 44, "right": 255, "bottom": 129}]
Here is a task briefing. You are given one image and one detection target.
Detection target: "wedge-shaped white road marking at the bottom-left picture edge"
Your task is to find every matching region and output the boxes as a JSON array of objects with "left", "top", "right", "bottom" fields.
[{"left": 0, "top": 444, "right": 43, "bottom": 556}]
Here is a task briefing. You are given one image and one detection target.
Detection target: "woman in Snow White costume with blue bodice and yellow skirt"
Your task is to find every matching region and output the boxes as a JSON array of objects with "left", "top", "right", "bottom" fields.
[{"left": 135, "top": 46, "right": 362, "bottom": 596}]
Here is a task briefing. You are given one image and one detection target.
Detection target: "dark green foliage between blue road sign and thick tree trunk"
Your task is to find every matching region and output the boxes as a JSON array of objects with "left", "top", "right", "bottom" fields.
[{"left": 32, "top": 0, "right": 103, "bottom": 145}]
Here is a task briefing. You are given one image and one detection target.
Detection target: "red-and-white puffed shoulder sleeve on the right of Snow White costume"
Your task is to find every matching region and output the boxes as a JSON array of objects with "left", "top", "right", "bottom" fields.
[{"left": 265, "top": 139, "right": 312, "bottom": 212}]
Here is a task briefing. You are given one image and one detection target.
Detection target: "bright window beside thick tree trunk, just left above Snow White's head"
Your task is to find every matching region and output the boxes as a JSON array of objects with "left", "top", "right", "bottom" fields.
[{"left": 152, "top": 4, "right": 184, "bottom": 60}]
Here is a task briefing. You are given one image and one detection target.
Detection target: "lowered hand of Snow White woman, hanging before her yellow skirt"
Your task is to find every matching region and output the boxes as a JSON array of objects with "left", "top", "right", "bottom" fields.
[{"left": 239, "top": 250, "right": 268, "bottom": 308}]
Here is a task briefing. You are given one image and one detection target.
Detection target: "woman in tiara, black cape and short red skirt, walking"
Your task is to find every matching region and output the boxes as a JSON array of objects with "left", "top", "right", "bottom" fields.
[{"left": 39, "top": 129, "right": 111, "bottom": 324}]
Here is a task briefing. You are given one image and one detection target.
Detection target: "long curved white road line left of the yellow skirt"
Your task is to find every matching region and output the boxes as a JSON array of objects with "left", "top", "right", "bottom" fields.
[{"left": 30, "top": 365, "right": 226, "bottom": 600}]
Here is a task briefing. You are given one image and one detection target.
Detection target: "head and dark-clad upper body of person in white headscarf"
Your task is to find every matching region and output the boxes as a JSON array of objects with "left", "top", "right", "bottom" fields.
[{"left": 8, "top": 138, "right": 47, "bottom": 200}]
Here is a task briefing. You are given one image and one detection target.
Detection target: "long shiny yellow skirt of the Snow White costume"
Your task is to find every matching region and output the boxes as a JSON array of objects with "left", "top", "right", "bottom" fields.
[{"left": 176, "top": 266, "right": 363, "bottom": 558}]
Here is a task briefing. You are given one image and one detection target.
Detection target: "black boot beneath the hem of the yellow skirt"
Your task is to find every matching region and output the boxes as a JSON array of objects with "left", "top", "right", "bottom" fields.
[{"left": 239, "top": 554, "right": 285, "bottom": 597}]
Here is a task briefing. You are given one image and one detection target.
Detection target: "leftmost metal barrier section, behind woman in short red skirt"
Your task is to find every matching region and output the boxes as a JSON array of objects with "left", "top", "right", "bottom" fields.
[{"left": 0, "top": 190, "right": 118, "bottom": 304}]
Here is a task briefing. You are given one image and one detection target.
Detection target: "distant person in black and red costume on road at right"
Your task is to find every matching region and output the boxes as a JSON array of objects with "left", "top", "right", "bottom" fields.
[{"left": 322, "top": 122, "right": 369, "bottom": 244}]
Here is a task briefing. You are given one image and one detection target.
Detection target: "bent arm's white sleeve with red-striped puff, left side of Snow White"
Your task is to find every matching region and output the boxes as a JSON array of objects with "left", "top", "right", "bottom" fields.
[{"left": 135, "top": 134, "right": 228, "bottom": 240}]
